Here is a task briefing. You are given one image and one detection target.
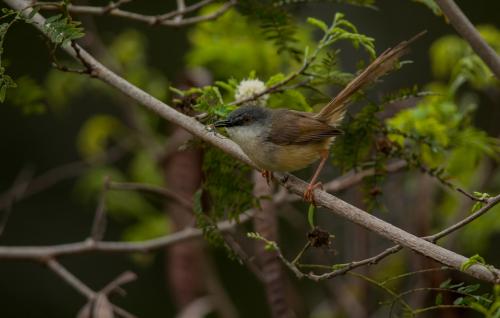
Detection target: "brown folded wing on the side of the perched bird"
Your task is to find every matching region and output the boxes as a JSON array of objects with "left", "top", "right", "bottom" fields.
[{"left": 267, "top": 109, "right": 342, "bottom": 146}]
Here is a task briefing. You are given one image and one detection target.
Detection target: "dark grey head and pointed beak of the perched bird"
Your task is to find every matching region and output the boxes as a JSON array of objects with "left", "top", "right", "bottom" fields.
[{"left": 214, "top": 106, "right": 271, "bottom": 130}]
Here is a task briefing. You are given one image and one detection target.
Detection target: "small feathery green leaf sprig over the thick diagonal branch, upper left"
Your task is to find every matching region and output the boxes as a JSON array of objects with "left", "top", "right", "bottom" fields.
[{"left": 43, "top": 14, "right": 85, "bottom": 45}]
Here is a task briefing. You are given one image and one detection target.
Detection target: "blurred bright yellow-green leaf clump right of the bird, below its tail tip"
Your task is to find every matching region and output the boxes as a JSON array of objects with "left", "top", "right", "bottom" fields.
[{"left": 387, "top": 90, "right": 500, "bottom": 181}]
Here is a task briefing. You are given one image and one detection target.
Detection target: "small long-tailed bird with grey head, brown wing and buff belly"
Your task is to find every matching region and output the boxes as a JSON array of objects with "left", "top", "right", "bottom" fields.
[{"left": 214, "top": 31, "right": 426, "bottom": 203}]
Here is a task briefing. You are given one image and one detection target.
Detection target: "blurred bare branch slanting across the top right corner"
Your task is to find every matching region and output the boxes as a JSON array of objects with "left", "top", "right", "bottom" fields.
[{"left": 436, "top": 0, "right": 500, "bottom": 79}]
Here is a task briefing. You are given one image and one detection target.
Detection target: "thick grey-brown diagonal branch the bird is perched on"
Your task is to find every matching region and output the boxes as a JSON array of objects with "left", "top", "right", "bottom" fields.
[{"left": 4, "top": 0, "right": 500, "bottom": 282}]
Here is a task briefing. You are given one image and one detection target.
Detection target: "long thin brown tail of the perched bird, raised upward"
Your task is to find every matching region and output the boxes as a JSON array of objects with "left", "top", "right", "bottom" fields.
[{"left": 315, "top": 31, "right": 427, "bottom": 125}]
